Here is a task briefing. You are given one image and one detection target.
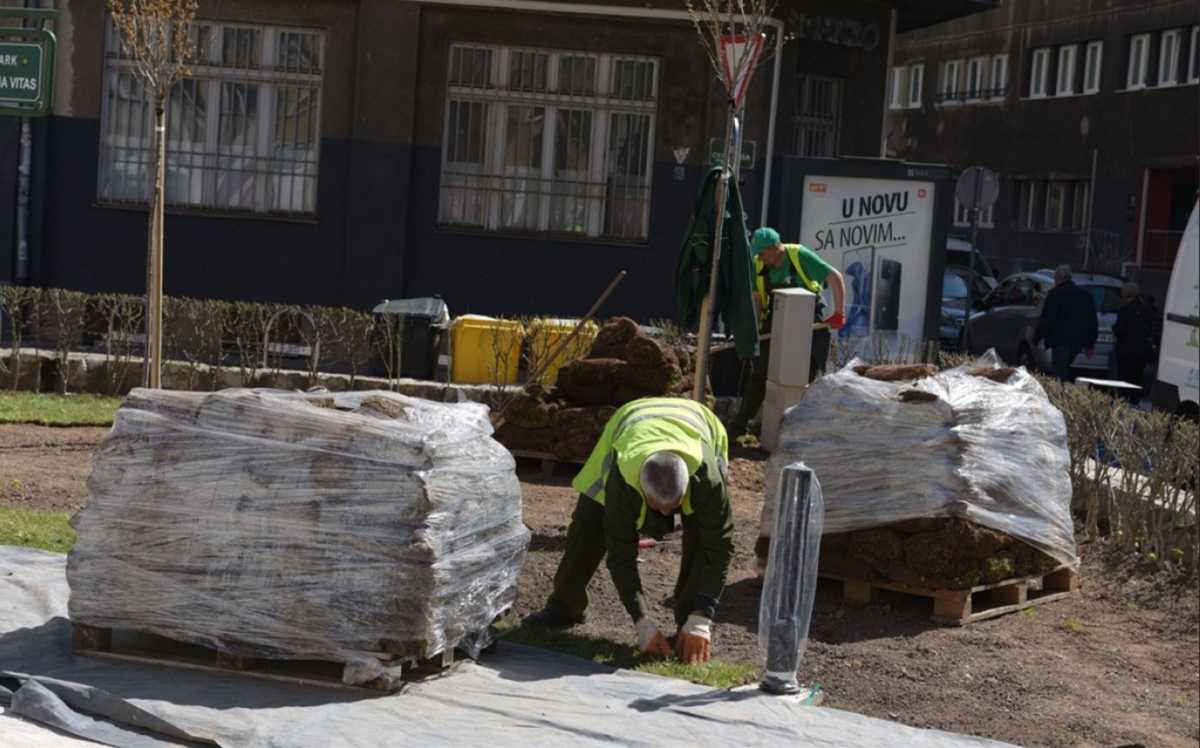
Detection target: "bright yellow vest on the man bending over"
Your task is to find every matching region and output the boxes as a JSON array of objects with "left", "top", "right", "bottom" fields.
[{"left": 571, "top": 397, "right": 730, "bottom": 529}]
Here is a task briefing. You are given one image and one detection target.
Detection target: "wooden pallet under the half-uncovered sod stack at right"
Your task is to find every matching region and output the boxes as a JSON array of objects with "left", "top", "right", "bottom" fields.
[{"left": 821, "top": 566, "right": 1079, "bottom": 626}]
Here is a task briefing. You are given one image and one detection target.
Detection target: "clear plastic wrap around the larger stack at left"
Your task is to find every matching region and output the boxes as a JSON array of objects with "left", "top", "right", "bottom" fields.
[{"left": 67, "top": 389, "right": 529, "bottom": 683}]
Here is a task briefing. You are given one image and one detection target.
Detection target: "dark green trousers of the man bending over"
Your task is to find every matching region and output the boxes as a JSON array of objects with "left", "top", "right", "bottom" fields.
[{"left": 546, "top": 494, "right": 702, "bottom": 626}]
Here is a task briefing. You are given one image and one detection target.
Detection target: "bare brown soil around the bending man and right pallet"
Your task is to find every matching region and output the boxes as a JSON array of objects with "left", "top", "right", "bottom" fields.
[{"left": 0, "top": 426, "right": 1200, "bottom": 747}]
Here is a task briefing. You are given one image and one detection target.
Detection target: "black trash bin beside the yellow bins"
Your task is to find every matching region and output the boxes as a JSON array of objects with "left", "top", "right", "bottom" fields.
[{"left": 371, "top": 297, "right": 449, "bottom": 379}]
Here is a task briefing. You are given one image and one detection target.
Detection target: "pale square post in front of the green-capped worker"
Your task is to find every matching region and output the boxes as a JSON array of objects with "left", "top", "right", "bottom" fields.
[{"left": 761, "top": 288, "right": 817, "bottom": 451}]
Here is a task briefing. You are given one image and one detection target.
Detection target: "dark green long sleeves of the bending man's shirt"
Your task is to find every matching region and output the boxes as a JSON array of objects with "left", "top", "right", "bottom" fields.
[{"left": 605, "top": 447, "right": 733, "bottom": 622}]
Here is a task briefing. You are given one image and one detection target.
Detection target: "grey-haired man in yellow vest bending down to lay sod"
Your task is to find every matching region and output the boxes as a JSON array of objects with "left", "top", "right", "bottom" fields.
[{"left": 526, "top": 397, "right": 733, "bottom": 663}]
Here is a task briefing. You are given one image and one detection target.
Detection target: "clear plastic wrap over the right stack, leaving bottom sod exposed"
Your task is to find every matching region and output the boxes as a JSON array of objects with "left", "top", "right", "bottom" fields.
[{"left": 762, "top": 352, "right": 1078, "bottom": 564}]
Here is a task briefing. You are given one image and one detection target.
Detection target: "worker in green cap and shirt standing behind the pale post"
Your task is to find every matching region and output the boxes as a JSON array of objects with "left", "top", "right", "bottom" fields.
[{"left": 730, "top": 226, "right": 846, "bottom": 436}]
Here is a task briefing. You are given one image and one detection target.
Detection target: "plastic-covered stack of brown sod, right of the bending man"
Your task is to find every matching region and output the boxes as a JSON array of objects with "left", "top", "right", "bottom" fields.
[{"left": 760, "top": 354, "right": 1078, "bottom": 609}]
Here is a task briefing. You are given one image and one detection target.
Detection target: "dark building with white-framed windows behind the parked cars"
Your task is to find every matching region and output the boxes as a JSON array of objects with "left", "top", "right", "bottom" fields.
[{"left": 884, "top": 0, "right": 1200, "bottom": 298}]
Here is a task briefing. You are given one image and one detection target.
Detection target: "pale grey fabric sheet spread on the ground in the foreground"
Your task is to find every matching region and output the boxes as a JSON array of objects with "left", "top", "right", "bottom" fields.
[{"left": 0, "top": 546, "right": 1003, "bottom": 748}]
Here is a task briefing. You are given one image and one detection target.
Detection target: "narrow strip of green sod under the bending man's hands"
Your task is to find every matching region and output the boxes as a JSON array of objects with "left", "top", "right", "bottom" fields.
[{"left": 497, "top": 623, "right": 757, "bottom": 688}]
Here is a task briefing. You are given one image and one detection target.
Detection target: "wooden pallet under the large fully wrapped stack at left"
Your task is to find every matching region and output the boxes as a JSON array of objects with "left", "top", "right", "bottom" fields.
[{"left": 71, "top": 623, "right": 454, "bottom": 692}]
